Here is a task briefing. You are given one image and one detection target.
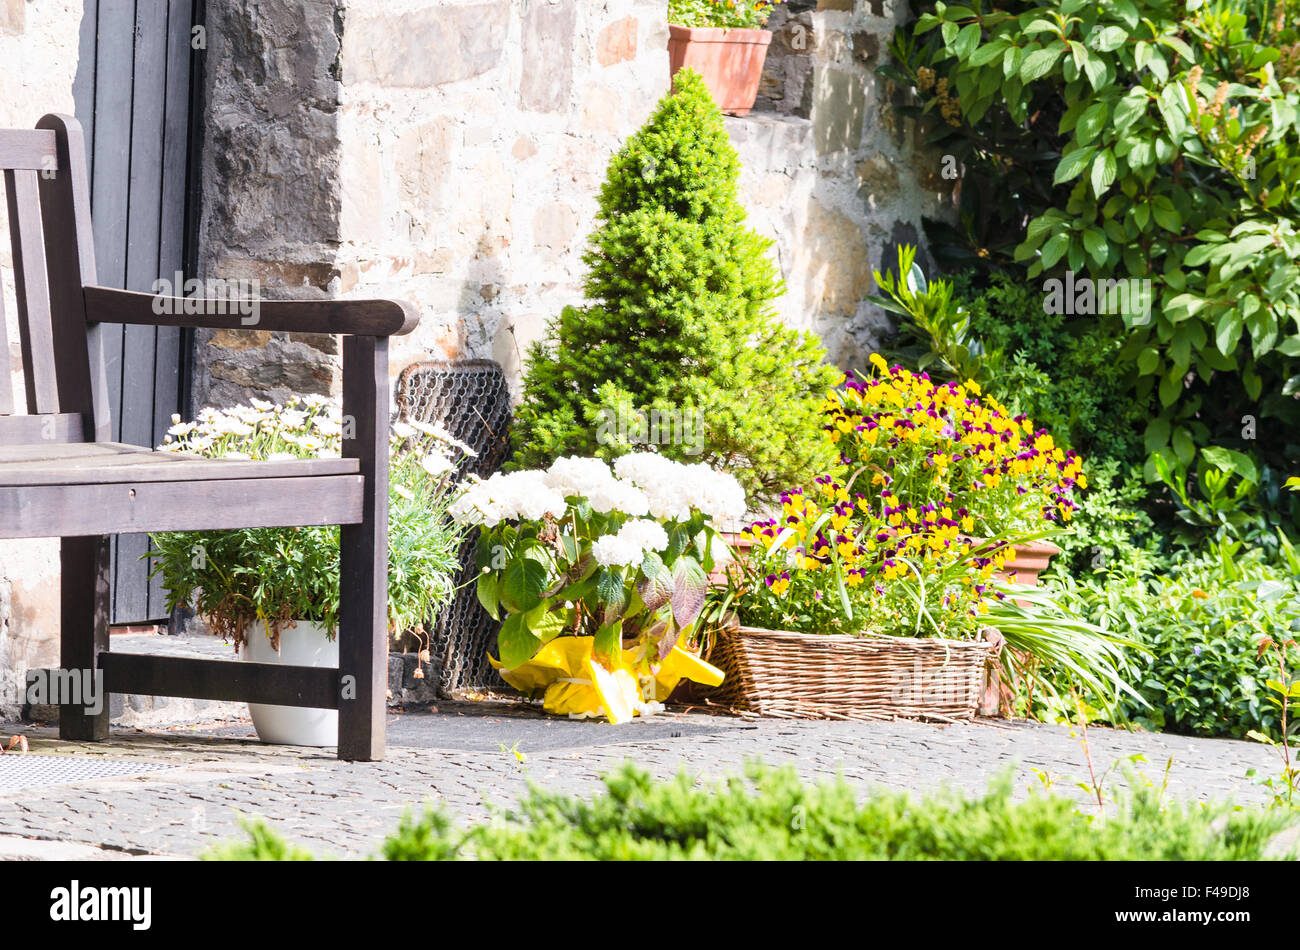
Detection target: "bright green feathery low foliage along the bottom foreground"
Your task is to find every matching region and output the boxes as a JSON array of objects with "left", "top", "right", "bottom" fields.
[{"left": 208, "top": 764, "right": 1290, "bottom": 860}]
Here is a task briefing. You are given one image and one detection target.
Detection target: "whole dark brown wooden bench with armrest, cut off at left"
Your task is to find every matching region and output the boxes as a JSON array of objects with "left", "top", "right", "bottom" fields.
[{"left": 0, "top": 114, "right": 419, "bottom": 760}]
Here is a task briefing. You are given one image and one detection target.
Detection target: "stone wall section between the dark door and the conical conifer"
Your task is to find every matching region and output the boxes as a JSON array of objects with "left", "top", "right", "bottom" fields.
[{"left": 195, "top": 0, "right": 668, "bottom": 404}]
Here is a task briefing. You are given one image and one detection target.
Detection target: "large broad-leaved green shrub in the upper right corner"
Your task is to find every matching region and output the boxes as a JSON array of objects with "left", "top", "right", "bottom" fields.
[{"left": 885, "top": 0, "right": 1300, "bottom": 535}]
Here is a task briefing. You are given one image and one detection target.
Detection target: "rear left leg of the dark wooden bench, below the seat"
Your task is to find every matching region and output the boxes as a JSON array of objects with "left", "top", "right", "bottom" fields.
[{"left": 59, "top": 535, "right": 109, "bottom": 742}]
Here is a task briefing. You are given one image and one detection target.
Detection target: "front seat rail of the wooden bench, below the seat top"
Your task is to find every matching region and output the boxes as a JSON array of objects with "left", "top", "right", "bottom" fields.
[{"left": 0, "top": 474, "right": 365, "bottom": 538}]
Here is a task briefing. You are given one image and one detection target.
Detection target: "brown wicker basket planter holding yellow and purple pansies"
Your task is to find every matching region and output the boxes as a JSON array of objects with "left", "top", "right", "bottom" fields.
[{"left": 709, "top": 626, "right": 993, "bottom": 720}]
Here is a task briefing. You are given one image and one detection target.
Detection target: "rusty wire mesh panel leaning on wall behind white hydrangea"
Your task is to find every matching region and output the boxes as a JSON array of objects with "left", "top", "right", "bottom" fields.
[{"left": 397, "top": 360, "right": 511, "bottom": 697}]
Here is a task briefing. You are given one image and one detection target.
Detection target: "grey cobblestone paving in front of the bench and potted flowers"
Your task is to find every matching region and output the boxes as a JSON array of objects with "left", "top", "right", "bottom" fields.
[{"left": 0, "top": 703, "right": 1278, "bottom": 858}]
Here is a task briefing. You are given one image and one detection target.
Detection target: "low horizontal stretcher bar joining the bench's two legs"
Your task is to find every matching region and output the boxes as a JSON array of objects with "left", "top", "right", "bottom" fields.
[{"left": 99, "top": 652, "right": 339, "bottom": 710}]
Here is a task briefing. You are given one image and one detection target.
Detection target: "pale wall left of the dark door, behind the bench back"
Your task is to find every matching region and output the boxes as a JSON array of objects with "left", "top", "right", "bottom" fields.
[{"left": 0, "top": 0, "right": 82, "bottom": 720}]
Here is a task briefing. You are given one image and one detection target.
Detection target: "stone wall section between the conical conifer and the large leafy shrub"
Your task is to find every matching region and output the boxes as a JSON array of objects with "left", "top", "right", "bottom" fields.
[{"left": 727, "top": 0, "right": 954, "bottom": 369}]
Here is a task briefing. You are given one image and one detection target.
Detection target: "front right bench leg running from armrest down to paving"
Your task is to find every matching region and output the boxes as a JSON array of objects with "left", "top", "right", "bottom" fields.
[{"left": 338, "top": 337, "right": 389, "bottom": 762}]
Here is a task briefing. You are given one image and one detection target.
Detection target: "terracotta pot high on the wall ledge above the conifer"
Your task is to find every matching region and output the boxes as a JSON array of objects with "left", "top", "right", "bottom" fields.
[{"left": 668, "top": 26, "right": 772, "bottom": 116}]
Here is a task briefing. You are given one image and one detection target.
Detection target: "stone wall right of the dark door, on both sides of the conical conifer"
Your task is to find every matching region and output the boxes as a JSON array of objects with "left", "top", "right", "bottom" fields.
[{"left": 195, "top": 0, "right": 961, "bottom": 405}]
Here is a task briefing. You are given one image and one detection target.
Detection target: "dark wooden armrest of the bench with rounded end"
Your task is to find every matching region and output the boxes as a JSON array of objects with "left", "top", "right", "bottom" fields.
[{"left": 82, "top": 286, "right": 420, "bottom": 337}]
